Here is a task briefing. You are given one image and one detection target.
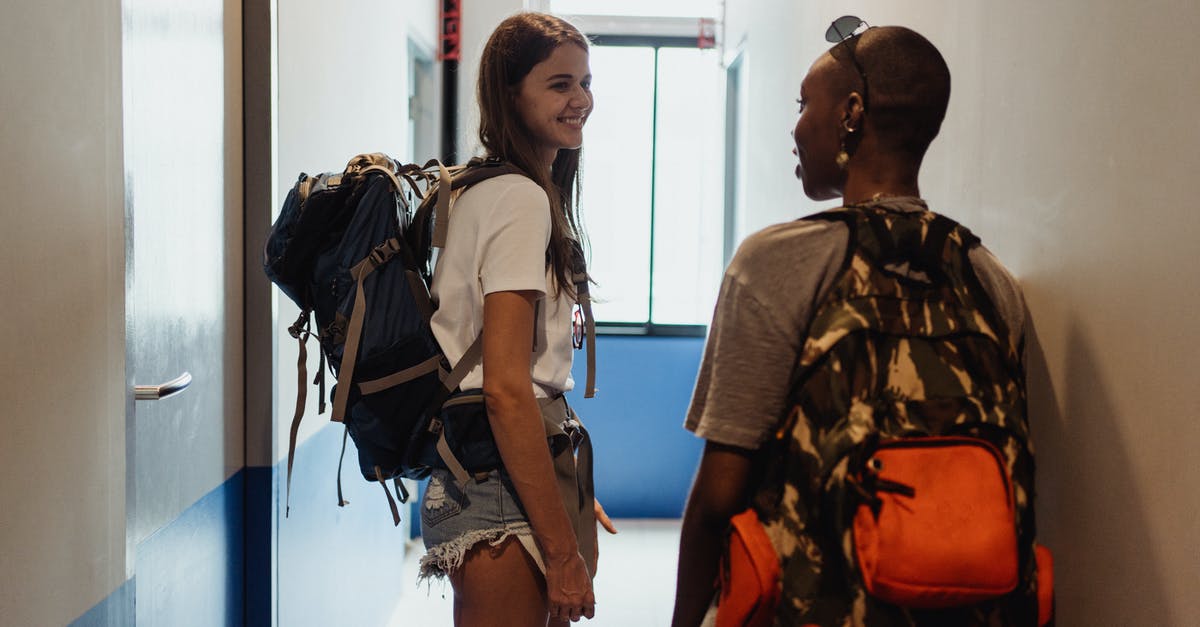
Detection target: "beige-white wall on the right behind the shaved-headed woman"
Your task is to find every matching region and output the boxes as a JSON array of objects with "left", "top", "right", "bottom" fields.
[{"left": 728, "top": 0, "right": 1200, "bottom": 627}]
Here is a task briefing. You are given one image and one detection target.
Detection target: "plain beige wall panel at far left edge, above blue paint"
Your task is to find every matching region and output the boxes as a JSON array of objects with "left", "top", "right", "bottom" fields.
[{"left": 0, "top": 0, "right": 130, "bottom": 625}]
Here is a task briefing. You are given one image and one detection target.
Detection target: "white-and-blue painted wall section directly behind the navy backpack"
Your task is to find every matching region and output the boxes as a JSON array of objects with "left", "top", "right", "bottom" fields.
[{"left": 267, "top": 0, "right": 438, "bottom": 626}]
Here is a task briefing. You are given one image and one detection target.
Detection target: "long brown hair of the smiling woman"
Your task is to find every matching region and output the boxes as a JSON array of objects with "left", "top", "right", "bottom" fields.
[{"left": 475, "top": 12, "right": 588, "bottom": 297}]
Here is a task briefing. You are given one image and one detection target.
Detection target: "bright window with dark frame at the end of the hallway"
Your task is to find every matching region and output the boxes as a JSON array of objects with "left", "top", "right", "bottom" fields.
[{"left": 554, "top": 1, "right": 726, "bottom": 335}]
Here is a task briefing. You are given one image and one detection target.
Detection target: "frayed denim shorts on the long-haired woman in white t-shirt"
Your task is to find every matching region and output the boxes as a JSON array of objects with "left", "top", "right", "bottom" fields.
[{"left": 420, "top": 470, "right": 541, "bottom": 579}]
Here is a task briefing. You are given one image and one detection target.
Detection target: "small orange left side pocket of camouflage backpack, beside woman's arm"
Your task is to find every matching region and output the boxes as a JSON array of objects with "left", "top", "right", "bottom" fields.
[{"left": 716, "top": 508, "right": 780, "bottom": 627}]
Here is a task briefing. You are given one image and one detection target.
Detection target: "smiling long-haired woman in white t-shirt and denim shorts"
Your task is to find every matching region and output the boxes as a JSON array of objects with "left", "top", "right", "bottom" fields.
[{"left": 421, "top": 13, "right": 611, "bottom": 627}]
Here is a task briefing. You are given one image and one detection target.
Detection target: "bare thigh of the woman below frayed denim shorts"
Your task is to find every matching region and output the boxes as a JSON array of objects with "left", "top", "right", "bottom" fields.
[{"left": 450, "top": 537, "right": 550, "bottom": 627}]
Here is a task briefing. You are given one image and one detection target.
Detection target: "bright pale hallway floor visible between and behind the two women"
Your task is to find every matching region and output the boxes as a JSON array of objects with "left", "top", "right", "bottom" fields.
[{"left": 389, "top": 520, "right": 679, "bottom": 627}]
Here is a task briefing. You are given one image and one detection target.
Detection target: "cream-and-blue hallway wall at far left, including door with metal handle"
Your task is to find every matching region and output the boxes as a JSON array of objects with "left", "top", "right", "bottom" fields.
[{"left": 0, "top": 0, "right": 242, "bottom": 625}]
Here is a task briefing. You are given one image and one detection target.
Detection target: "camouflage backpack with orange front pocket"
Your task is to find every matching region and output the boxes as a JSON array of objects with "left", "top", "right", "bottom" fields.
[{"left": 754, "top": 205, "right": 1037, "bottom": 627}]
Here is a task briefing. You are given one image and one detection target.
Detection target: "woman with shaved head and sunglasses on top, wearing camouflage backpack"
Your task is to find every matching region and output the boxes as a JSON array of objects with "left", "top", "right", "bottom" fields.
[{"left": 673, "top": 17, "right": 1039, "bottom": 627}]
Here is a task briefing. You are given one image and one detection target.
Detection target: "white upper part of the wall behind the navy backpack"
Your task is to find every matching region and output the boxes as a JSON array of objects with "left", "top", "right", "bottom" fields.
[{"left": 272, "top": 0, "right": 438, "bottom": 461}]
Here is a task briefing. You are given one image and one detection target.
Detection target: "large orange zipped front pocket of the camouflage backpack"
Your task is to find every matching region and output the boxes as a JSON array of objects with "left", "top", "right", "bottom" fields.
[{"left": 853, "top": 437, "right": 1019, "bottom": 608}]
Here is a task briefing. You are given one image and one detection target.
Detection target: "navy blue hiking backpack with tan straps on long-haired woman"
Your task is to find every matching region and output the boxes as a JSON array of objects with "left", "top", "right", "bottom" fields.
[{"left": 263, "top": 153, "right": 549, "bottom": 525}]
